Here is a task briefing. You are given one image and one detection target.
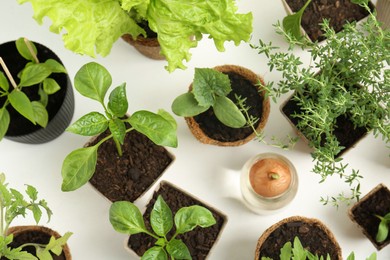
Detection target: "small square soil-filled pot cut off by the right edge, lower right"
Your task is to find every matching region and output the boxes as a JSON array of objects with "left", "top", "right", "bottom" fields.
[{"left": 348, "top": 184, "right": 390, "bottom": 250}]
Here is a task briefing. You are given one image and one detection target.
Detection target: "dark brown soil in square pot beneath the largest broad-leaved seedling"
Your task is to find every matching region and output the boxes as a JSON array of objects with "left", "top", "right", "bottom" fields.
[{"left": 90, "top": 127, "right": 173, "bottom": 202}]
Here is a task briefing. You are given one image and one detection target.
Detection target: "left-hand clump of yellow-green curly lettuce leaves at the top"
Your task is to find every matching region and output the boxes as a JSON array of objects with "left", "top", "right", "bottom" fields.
[{"left": 18, "top": 0, "right": 145, "bottom": 57}]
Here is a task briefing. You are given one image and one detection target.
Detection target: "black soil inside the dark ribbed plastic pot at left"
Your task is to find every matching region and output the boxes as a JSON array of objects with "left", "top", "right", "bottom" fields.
[{"left": 0, "top": 42, "right": 69, "bottom": 136}]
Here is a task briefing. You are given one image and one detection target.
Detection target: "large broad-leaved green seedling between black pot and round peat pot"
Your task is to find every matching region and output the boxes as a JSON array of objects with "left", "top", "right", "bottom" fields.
[{"left": 61, "top": 62, "right": 177, "bottom": 191}]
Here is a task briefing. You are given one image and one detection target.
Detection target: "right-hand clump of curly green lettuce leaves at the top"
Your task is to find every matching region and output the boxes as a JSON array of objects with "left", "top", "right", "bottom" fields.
[{"left": 147, "top": 0, "right": 253, "bottom": 72}]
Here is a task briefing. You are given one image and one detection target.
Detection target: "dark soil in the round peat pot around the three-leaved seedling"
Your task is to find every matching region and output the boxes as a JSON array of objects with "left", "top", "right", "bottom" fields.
[{"left": 194, "top": 73, "right": 263, "bottom": 142}]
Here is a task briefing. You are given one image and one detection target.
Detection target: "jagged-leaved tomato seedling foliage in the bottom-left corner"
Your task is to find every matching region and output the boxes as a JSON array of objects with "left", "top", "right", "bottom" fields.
[{"left": 0, "top": 173, "right": 72, "bottom": 260}]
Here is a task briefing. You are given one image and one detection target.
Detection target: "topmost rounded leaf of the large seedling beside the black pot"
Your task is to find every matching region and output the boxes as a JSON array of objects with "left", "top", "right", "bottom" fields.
[{"left": 74, "top": 62, "right": 112, "bottom": 104}]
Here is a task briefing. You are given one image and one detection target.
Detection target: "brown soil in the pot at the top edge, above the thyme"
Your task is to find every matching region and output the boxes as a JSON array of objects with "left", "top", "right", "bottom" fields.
[{"left": 286, "top": 0, "right": 373, "bottom": 42}]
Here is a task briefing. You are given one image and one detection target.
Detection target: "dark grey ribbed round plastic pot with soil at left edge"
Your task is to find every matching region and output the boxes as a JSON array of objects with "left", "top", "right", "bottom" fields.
[{"left": 0, "top": 41, "right": 74, "bottom": 144}]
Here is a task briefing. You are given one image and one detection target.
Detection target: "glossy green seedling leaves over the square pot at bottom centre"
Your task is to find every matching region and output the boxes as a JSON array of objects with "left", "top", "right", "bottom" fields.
[{"left": 110, "top": 195, "right": 216, "bottom": 260}]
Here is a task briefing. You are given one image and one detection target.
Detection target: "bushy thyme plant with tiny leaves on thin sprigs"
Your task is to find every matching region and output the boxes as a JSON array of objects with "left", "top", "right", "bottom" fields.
[{"left": 252, "top": 1, "right": 390, "bottom": 206}]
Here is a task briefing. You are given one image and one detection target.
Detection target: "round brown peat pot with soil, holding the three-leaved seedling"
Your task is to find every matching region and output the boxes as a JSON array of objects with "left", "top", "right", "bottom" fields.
[{"left": 185, "top": 65, "right": 270, "bottom": 146}]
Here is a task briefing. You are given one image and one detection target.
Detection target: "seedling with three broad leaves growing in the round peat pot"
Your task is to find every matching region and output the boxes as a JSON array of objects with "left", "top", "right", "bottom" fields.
[{"left": 172, "top": 68, "right": 246, "bottom": 128}]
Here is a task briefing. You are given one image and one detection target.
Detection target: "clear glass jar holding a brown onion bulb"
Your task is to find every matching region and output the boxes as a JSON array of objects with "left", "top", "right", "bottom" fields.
[{"left": 241, "top": 153, "right": 298, "bottom": 214}]
